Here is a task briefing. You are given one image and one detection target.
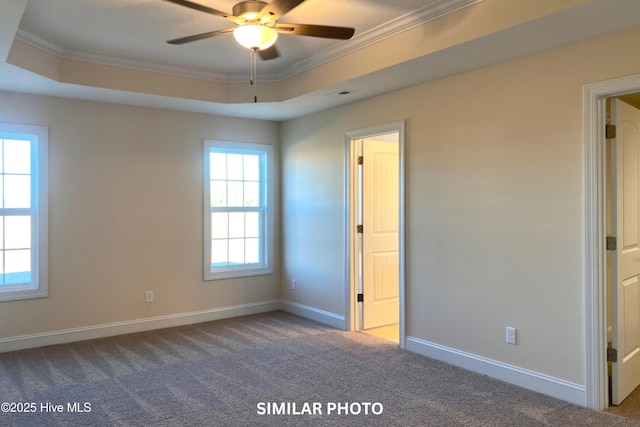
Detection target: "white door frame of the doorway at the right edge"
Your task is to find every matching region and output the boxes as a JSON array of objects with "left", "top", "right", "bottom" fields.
[{"left": 584, "top": 74, "right": 640, "bottom": 410}]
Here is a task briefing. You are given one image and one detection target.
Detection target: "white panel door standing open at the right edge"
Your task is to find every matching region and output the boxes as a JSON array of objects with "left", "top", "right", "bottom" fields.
[{"left": 611, "top": 99, "right": 640, "bottom": 405}]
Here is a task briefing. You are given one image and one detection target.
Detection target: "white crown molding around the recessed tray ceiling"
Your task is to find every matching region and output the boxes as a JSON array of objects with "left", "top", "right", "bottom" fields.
[{"left": 16, "top": 0, "right": 483, "bottom": 83}]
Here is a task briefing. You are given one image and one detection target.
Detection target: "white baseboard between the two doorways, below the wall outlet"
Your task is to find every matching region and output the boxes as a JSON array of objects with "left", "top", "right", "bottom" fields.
[{"left": 406, "top": 337, "right": 587, "bottom": 407}]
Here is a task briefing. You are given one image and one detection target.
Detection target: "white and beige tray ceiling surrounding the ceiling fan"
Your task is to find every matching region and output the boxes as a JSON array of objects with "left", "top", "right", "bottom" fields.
[{"left": 0, "top": 0, "right": 640, "bottom": 120}]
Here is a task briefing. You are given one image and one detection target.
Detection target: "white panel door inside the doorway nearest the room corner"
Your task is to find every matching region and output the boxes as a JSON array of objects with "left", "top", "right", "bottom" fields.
[{"left": 362, "top": 134, "right": 400, "bottom": 329}]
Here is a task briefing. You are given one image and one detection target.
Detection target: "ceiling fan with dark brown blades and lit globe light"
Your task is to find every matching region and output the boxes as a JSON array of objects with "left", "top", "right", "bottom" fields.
[{"left": 166, "top": 0, "right": 355, "bottom": 60}]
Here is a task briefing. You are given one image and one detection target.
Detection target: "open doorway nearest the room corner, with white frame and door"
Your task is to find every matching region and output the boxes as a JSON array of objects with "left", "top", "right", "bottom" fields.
[{"left": 346, "top": 122, "right": 405, "bottom": 347}]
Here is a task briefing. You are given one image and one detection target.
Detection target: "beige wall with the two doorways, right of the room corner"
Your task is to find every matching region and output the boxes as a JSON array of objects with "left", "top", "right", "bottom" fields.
[{"left": 281, "top": 25, "right": 640, "bottom": 384}]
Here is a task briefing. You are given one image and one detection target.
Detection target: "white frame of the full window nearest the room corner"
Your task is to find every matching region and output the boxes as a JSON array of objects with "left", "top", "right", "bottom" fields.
[{"left": 203, "top": 139, "right": 274, "bottom": 280}]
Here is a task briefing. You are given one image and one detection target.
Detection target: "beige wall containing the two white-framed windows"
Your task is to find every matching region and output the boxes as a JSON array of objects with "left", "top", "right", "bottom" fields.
[{"left": 0, "top": 92, "right": 280, "bottom": 338}]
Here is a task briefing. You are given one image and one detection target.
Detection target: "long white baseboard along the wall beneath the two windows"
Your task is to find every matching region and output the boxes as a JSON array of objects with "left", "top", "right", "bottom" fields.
[{"left": 0, "top": 300, "right": 281, "bottom": 353}]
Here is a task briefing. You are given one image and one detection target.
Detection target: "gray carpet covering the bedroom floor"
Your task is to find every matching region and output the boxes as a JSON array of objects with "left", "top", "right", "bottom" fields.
[{"left": 0, "top": 312, "right": 640, "bottom": 427}]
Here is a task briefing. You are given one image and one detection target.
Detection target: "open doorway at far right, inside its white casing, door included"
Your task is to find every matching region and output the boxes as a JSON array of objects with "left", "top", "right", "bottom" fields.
[{"left": 605, "top": 94, "right": 640, "bottom": 418}]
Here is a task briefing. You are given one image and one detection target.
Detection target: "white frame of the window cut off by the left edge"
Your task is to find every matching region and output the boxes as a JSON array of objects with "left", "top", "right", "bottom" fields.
[{"left": 0, "top": 123, "right": 49, "bottom": 302}]
